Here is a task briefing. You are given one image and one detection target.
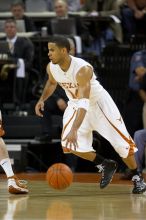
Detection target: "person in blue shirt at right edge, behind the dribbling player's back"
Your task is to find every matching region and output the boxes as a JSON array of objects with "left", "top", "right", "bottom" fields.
[{"left": 125, "top": 50, "right": 146, "bottom": 137}]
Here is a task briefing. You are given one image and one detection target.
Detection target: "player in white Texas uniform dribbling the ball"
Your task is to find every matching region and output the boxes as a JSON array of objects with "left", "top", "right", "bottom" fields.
[{"left": 35, "top": 36, "right": 146, "bottom": 194}]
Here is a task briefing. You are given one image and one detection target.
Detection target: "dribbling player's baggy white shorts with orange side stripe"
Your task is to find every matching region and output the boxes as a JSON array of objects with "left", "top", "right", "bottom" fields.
[{"left": 62, "top": 89, "right": 137, "bottom": 158}]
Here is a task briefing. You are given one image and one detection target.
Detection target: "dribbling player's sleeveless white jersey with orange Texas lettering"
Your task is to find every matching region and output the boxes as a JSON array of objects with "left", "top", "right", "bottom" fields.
[{"left": 50, "top": 56, "right": 103, "bottom": 103}]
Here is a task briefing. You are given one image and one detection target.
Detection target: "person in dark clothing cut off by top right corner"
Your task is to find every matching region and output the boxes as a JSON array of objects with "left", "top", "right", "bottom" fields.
[{"left": 122, "top": 0, "right": 146, "bottom": 40}]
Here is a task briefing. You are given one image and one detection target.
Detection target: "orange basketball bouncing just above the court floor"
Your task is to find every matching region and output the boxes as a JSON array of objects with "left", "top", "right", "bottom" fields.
[{"left": 46, "top": 163, "right": 73, "bottom": 190}]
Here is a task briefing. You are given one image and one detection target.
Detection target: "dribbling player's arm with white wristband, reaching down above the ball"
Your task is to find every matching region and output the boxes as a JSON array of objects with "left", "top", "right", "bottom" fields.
[{"left": 64, "top": 66, "right": 93, "bottom": 149}]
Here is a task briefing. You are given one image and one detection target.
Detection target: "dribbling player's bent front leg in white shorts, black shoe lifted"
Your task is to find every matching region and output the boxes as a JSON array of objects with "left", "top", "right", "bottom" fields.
[{"left": 62, "top": 105, "right": 117, "bottom": 188}]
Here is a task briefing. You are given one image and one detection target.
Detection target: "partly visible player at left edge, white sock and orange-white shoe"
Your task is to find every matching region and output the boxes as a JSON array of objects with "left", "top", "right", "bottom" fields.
[{"left": 0, "top": 111, "right": 28, "bottom": 194}]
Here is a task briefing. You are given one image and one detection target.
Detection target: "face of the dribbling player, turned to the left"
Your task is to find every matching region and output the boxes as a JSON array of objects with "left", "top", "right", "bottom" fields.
[{"left": 48, "top": 43, "right": 64, "bottom": 64}]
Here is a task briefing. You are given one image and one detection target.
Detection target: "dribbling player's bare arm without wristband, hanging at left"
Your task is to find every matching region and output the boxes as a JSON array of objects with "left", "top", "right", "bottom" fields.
[{"left": 35, "top": 64, "right": 57, "bottom": 117}]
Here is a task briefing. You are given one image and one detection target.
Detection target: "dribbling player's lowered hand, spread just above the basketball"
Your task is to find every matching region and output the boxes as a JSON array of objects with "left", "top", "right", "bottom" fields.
[{"left": 63, "top": 130, "right": 78, "bottom": 150}]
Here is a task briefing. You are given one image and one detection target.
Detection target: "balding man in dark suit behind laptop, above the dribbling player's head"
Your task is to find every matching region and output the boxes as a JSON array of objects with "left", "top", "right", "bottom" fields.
[{"left": 48, "top": 0, "right": 92, "bottom": 52}]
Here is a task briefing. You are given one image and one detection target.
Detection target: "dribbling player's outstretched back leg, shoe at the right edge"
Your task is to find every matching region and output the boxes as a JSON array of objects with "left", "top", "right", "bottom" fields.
[{"left": 92, "top": 88, "right": 146, "bottom": 193}]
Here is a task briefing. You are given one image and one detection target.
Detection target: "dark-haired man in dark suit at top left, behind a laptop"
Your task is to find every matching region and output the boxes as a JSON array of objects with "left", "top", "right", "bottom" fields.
[{"left": 11, "top": 0, "right": 36, "bottom": 32}]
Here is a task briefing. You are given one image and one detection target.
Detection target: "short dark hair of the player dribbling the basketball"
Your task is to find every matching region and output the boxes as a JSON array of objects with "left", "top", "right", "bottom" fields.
[{"left": 49, "top": 36, "right": 70, "bottom": 53}]
